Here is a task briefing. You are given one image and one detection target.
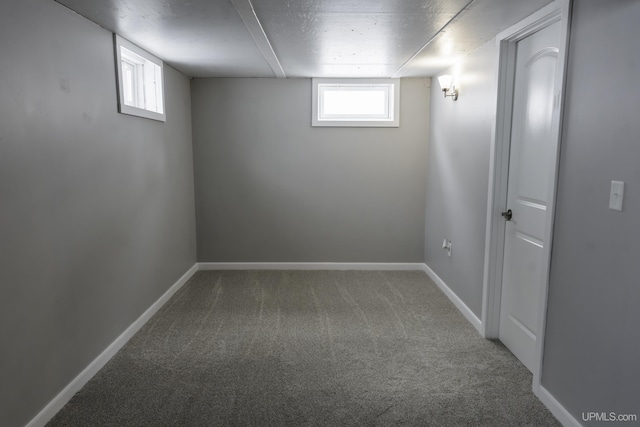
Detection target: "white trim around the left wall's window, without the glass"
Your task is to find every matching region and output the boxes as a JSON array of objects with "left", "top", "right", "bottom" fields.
[{"left": 113, "top": 34, "right": 166, "bottom": 122}]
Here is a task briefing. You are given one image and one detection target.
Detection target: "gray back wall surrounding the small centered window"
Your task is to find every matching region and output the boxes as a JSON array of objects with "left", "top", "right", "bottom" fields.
[{"left": 191, "top": 79, "right": 430, "bottom": 262}]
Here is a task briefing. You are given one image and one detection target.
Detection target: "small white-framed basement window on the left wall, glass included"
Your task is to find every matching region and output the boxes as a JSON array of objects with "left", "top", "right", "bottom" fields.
[{"left": 114, "top": 34, "right": 166, "bottom": 122}]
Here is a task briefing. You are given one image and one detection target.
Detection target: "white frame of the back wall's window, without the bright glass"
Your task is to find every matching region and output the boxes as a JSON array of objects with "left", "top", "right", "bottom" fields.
[{"left": 311, "top": 78, "right": 400, "bottom": 127}]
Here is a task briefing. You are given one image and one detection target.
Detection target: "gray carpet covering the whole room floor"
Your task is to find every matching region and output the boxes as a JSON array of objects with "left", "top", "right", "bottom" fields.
[{"left": 48, "top": 271, "right": 559, "bottom": 426}]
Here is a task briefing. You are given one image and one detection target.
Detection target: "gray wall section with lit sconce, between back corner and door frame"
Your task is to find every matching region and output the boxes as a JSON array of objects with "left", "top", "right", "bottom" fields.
[{"left": 425, "top": 41, "right": 497, "bottom": 318}]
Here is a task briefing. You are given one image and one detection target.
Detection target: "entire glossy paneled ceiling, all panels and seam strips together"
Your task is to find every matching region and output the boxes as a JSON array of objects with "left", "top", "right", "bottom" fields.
[{"left": 55, "top": 0, "right": 552, "bottom": 77}]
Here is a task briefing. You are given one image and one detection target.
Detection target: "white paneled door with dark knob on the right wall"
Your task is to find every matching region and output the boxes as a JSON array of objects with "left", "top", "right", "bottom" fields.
[{"left": 499, "top": 22, "right": 560, "bottom": 371}]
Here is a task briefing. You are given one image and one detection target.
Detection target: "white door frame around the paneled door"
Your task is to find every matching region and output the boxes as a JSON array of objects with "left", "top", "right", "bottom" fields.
[{"left": 482, "top": 0, "right": 572, "bottom": 391}]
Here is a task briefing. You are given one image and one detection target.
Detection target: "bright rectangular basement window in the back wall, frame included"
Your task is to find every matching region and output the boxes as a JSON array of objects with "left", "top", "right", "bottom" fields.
[{"left": 312, "top": 79, "right": 400, "bottom": 127}]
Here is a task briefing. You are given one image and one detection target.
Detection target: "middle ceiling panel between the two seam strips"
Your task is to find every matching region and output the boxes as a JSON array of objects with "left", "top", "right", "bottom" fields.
[{"left": 253, "top": 0, "right": 469, "bottom": 77}]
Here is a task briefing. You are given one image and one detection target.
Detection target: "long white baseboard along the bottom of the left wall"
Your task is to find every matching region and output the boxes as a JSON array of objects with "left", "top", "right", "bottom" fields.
[{"left": 26, "top": 264, "right": 198, "bottom": 427}]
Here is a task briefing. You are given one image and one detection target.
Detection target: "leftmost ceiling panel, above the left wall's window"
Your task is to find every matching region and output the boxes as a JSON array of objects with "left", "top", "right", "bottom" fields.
[{"left": 56, "top": 0, "right": 274, "bottom": 77}]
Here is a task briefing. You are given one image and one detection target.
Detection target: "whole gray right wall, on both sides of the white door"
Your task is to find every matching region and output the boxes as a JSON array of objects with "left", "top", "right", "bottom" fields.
[{"left": 425, "top": 0, "right": 640, "bottom": 425}]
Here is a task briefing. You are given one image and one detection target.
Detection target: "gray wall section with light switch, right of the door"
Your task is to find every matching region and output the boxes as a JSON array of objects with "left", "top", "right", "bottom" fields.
[{"left": 542, "top": 0, "right": 640, "bottom": 425}]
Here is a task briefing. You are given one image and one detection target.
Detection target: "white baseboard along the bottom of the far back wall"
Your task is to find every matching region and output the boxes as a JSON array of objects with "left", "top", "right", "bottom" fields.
[{"left": 198, "top": 262, "right": 424, "bottom": 271}]
